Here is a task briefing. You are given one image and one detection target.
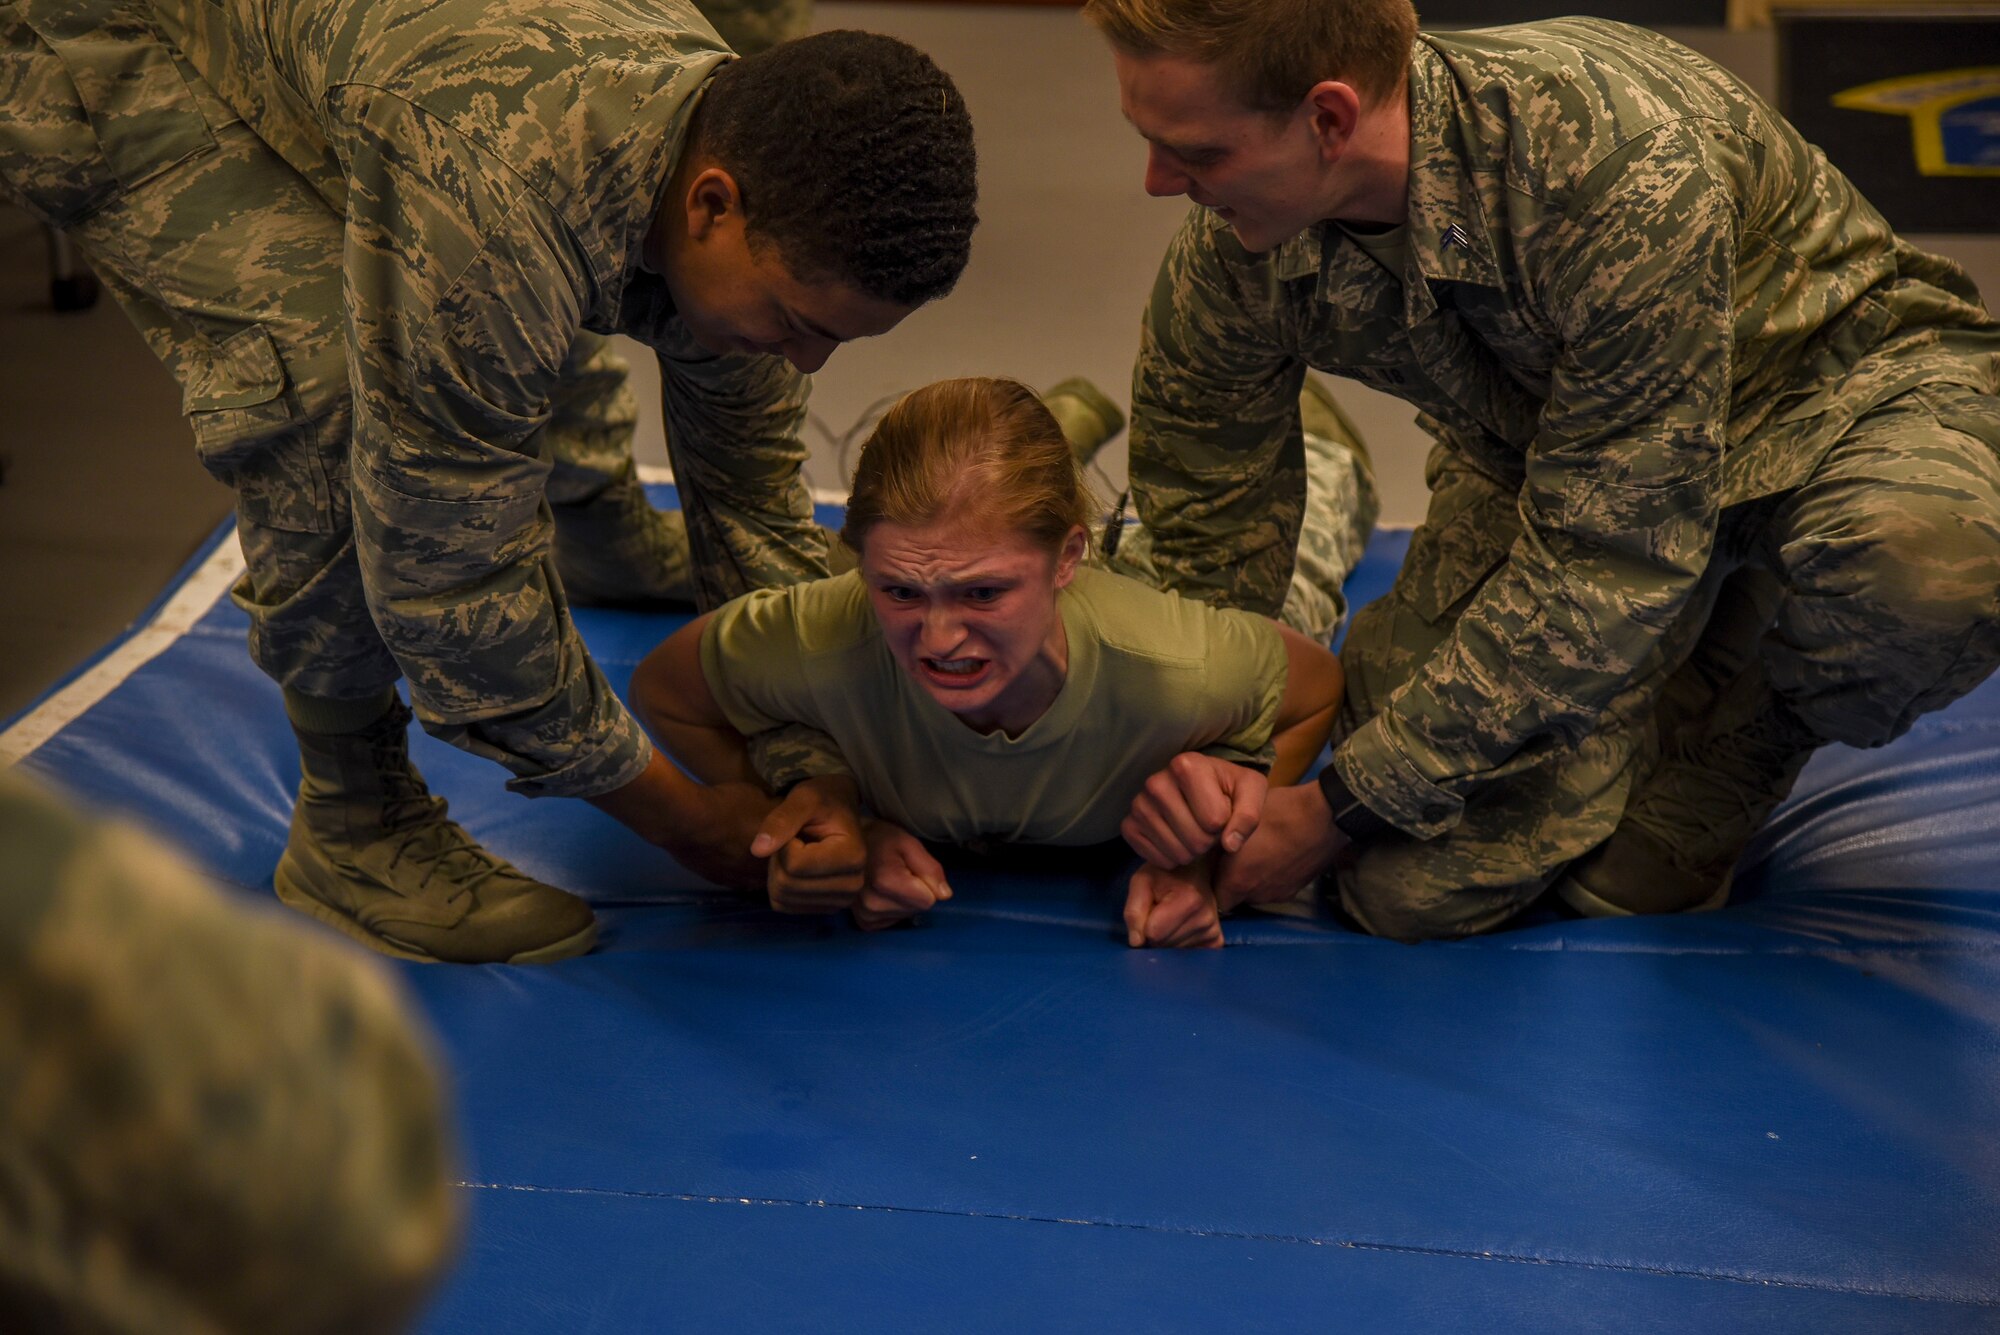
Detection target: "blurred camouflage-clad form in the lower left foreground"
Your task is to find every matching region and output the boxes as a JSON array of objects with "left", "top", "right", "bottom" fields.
[{"left": 0, "top": 775, "right": 456, "bottom": 1335}]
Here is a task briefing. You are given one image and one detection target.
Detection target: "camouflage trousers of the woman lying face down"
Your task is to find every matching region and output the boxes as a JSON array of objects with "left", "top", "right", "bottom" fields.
[{"left": 1098, "top": 419, "right": 1382, "bottom": 644}]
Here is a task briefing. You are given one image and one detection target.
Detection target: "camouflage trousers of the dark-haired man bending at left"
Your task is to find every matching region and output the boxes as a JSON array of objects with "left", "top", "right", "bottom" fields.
[{"left": 0, "top": 0, "right": 702, "bottom": 699}]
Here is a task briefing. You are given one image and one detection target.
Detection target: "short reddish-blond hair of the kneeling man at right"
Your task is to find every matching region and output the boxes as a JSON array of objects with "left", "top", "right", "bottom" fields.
[{"left": 1084, "top": 0, "right": 1416, "bottom": 114}]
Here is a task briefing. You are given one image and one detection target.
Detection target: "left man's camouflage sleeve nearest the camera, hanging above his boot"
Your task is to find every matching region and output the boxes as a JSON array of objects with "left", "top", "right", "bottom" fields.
[{"left": 338, "top": 88, "right": 652, "bottom": 797}]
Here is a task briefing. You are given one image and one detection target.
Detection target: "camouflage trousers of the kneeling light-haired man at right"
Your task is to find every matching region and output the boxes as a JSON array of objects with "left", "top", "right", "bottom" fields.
[{"left": 1334, "top": 386, "right": 2000, "bottom": 939}]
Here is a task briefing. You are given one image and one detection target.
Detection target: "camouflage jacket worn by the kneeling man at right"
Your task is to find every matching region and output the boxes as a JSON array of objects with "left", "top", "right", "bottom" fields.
[{"left": 1132, "top": 20, "right": 2000, "bottom": 837}]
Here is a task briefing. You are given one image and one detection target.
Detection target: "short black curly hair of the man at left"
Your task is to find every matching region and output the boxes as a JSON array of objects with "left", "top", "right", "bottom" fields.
[{"left": 692, "top": 32, "right": 978, "bottom": 306}]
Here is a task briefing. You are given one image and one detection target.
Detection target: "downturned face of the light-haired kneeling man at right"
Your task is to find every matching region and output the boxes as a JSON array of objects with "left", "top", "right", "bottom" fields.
[{"left": 1112, "top": 46, "right": 1324, "bottom": 252}]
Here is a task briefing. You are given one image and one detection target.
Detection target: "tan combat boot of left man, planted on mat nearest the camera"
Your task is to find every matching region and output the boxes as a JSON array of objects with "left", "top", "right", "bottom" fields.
[{"left": 276, "top": 699, "right": 598, "bottom": 963}]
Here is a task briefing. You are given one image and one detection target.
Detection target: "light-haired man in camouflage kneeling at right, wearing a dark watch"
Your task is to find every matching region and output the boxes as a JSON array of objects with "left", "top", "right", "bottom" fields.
[{"left": 1086, "top": 0, "right": 2000, "bottom": 939}]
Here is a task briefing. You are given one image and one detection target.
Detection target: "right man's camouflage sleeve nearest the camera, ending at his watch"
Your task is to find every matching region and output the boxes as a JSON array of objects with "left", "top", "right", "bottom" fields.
[{"left": 1334, "top": 124, "right": 1736, "bottom": 837}]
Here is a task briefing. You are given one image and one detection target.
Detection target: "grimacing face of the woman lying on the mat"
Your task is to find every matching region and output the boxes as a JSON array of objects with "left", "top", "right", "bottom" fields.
[{"left": 860, "top": 512, "right": 1086, "bottom": 735}]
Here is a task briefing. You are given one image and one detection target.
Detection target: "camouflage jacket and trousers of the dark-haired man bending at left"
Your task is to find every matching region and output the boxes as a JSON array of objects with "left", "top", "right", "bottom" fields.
[{"left": 0, "top": 0, "right": 826, "bottom": 795}]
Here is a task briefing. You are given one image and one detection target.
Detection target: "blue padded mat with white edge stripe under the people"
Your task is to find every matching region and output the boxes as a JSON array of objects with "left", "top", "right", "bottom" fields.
[{"left": 0, "top": 487, "right": 2000, "bottom": 1335}]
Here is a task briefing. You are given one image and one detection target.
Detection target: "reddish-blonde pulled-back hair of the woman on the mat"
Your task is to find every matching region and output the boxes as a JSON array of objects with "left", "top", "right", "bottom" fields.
[{"left": 840, "top": 376, "right": 1100, "bottom": 554}]
